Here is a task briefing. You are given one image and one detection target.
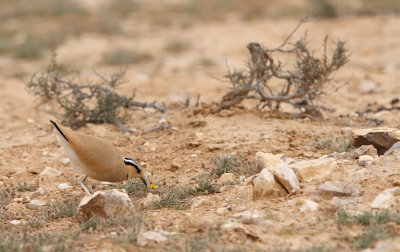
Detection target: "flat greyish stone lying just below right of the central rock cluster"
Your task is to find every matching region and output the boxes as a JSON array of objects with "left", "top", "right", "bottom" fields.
[{"left": 318, "top": 181, "right": 361, "bottom": 197}]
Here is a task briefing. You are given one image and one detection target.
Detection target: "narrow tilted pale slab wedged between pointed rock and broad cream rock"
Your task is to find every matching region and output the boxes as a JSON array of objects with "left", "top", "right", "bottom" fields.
[{"left": 271, "top": 164, "right": 300, "bottom": 193}]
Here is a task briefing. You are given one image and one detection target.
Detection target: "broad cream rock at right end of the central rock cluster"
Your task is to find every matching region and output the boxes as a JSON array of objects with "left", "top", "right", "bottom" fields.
[{"left": 289, "top": 158, "right": 337, "bottom": 182}]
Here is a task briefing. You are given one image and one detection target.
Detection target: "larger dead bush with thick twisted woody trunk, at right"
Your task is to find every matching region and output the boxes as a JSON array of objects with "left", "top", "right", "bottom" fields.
[{"left": 214, "top": 18, "right": 349, "bottom": 116}]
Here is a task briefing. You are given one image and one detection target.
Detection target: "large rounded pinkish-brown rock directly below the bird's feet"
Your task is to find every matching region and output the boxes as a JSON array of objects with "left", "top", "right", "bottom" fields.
[{"left": 78, "top": 189, "right": 135, "bottom": 221}]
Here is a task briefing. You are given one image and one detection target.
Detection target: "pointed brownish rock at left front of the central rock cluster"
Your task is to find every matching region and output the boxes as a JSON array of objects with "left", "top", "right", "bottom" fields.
[{"left": 252, "top": 168, "right": 286, "bottom": 200}]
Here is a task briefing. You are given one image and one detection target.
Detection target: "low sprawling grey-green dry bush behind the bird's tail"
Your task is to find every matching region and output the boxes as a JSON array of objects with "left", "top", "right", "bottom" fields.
[{"left": 26, "top": 53, "right": 165, "bottom": 128}]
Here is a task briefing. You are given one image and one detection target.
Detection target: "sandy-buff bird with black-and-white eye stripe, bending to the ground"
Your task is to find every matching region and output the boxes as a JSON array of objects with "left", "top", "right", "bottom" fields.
[{"left": 50, "top": 121, "right": 147, "bottom": 195}]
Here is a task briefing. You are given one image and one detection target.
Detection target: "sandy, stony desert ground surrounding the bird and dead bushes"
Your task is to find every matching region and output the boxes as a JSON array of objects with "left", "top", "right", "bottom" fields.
[{"left": 0, "top": 0, "right": 400, "bottom": 251}]
